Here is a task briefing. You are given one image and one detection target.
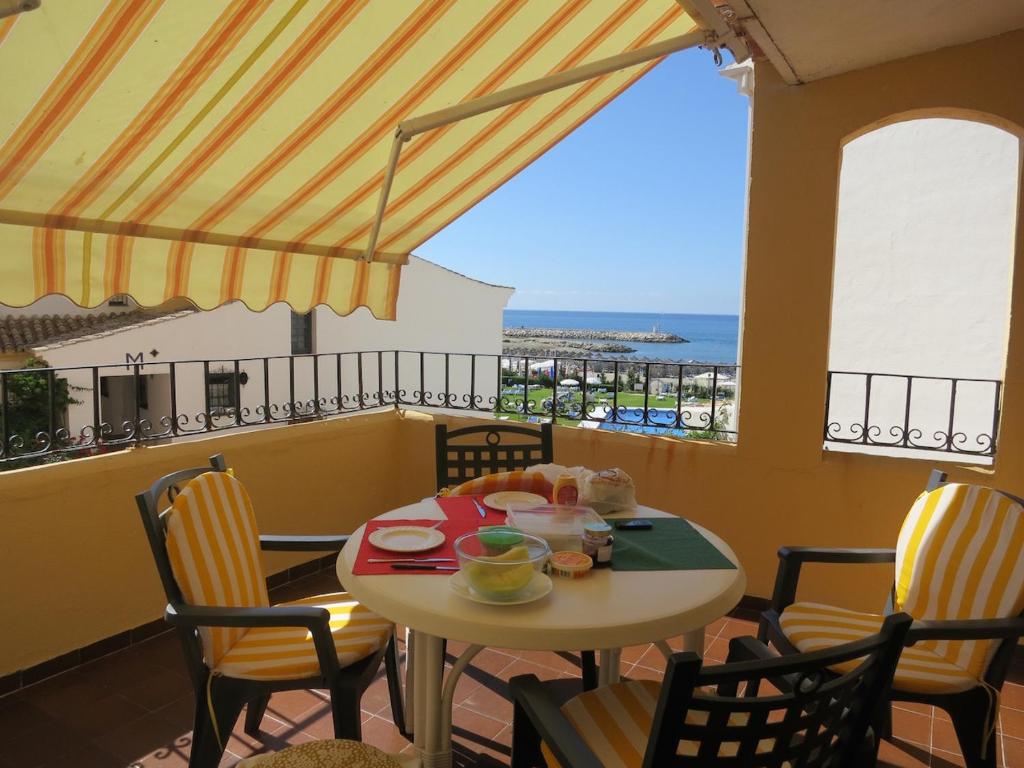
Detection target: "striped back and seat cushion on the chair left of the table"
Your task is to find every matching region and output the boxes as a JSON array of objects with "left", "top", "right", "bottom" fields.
[{"left": 166, "top": 472, "right": 393, "bottom": 680}]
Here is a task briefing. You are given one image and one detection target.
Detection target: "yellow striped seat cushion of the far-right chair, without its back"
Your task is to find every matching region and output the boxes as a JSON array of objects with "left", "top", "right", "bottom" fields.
[{"left": 780, "top": 602, "right": 981, "bottom": 693}]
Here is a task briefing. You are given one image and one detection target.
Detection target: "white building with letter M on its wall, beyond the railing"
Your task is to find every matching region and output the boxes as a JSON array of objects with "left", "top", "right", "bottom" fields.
[{"left": 0, "top": 256, "right": 513, "bottom": 437}]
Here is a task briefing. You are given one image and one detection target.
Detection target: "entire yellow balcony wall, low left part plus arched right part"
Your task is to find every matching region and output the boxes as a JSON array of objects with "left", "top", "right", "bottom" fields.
[{"left": 0, "top": 32, "right": 1024, "bottom": 675}]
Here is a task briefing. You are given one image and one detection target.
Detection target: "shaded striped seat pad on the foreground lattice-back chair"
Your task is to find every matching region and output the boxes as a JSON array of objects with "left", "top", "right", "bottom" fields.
[{"left": 541, "top": 680, "right": 770, "bottom": 768}]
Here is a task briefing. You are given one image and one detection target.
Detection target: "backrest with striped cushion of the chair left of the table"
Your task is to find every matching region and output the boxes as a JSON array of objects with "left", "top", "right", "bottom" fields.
[{"left": 136, "top": 456, "right": 270, "bottom": 666}]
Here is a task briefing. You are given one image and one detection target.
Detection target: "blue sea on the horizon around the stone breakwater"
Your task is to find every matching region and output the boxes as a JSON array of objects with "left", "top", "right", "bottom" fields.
[{"left": 505, "top": 309, "right": 739, "bottom": 362}]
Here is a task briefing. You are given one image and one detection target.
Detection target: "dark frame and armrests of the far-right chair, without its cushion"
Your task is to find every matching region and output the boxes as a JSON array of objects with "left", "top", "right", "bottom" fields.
[{"left": 758, "top": 470, "right": 1024, "bottom": 768}]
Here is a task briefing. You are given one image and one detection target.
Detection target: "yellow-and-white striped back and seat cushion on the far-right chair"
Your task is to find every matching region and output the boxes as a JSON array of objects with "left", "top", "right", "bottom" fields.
[{"left": 781, "top": 483, "right": 1024, "bottom": 692}]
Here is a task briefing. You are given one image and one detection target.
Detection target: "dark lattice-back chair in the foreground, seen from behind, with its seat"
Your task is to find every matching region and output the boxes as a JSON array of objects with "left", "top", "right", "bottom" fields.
[{"left": 511, "top": 613, "right": 911, "bottom": 768}]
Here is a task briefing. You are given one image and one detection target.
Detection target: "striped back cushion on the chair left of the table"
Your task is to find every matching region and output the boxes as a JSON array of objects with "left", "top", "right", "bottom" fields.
[{"left": 166, "top": 472, "right": 270, "bottom": 667}]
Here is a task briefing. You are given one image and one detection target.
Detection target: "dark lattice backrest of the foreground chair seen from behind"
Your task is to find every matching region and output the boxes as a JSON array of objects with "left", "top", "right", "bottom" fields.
[{"left": 629, "top": 613, "right": 911, "bottom": 768}]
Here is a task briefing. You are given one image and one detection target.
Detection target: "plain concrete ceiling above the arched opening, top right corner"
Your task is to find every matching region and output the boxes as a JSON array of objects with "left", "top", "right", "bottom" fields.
[{"left": 733, "top": 0, "right": 1024, "bottom": 83}]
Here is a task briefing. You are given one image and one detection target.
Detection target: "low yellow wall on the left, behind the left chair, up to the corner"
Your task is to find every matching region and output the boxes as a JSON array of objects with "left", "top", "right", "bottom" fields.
[{"left": 0, "top": 412, "right": 419, "bottom": 676}]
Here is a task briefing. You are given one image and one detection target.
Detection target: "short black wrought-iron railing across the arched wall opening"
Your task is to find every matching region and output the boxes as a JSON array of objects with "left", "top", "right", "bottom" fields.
[{"left": 824, "top": 371, "right": 1002, "bottom": 457}]
